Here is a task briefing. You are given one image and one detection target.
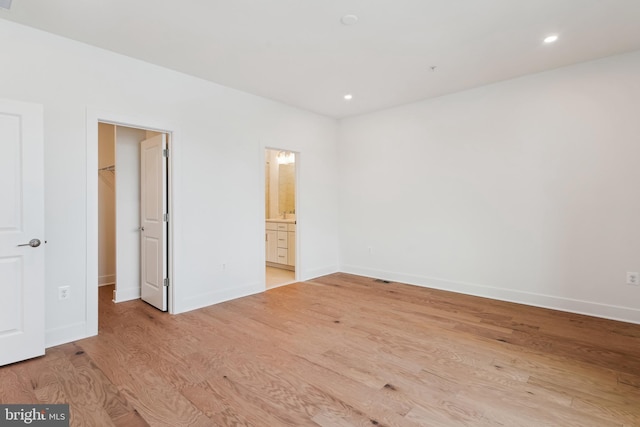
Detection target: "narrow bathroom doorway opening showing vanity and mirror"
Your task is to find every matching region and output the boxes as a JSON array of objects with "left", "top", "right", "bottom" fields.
[{"left": 264, "top": 148, "right": 298, "bottom": 289}]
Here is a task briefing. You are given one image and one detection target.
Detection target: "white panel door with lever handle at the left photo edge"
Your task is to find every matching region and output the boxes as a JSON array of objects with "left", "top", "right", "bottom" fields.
[{"left": 0, "top": 100, "right": 44, "bottom": 365}]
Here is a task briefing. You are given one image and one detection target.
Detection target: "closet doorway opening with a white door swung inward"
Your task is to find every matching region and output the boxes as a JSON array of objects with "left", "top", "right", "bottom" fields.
[{"left": 98, "top": 122, "right": 170, "bottom": 311}]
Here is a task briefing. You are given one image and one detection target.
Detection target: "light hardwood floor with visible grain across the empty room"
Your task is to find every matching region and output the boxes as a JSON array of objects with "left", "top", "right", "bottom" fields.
[{"left": 0, "top": 274, "right": 640, "bottom": 427}]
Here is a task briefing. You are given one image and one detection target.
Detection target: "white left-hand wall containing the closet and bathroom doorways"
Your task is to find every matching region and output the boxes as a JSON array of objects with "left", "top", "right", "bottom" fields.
[{"left": 0, "top": 20, "right": 338, "bottom": 346}]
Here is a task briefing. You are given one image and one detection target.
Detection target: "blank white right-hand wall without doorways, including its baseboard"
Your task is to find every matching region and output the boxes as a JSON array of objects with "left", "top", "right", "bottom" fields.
[{"left": 339, "top": 52, "right": 640, "bottom": 322}]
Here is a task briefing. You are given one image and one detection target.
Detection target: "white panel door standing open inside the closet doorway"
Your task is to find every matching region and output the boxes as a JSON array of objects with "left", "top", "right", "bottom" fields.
[{"left": 140, "top": 134, "right": 168, "bottom": 311}]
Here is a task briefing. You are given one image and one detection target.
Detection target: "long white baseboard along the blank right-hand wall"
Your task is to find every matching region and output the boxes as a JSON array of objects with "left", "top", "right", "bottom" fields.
[{"left": 341, "top": 265, "right": 640, "bottom": 324}]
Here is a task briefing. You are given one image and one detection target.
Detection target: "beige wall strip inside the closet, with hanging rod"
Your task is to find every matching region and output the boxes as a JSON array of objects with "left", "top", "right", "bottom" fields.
[{"left": 96, "top": 123, "right": 116, "bottom": 286}]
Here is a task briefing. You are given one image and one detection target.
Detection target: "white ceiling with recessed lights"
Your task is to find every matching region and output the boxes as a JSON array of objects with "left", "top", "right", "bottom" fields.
[{"left": 0, "top": 0, "right": 640, "bottom": 117}]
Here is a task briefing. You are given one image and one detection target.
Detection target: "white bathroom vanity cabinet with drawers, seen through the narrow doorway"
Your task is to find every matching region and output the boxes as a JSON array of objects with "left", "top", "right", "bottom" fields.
[{"left": 265, "top": 220, "right": 296, "bottom": 270}]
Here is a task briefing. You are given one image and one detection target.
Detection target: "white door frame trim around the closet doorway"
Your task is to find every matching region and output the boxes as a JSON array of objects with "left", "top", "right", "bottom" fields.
[{"left": 86, "top": 108, "right": 180, "bottom": 336}]
